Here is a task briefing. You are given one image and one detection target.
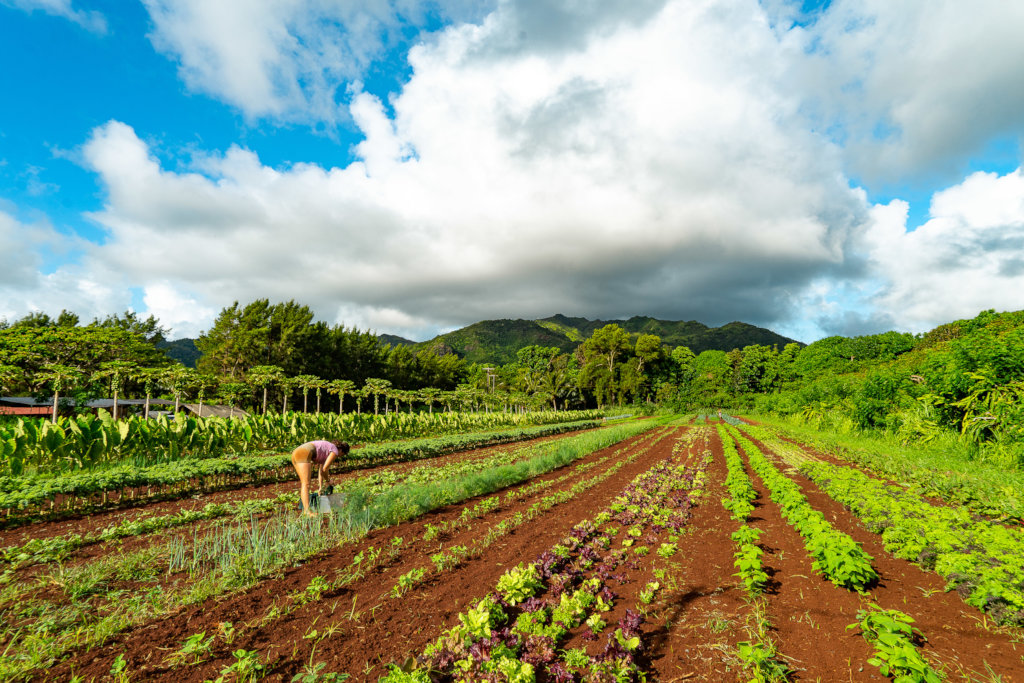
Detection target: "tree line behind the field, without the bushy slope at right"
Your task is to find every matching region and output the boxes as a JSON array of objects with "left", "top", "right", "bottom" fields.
[{"left": 0, "top": 299, "right": 799, "bottom": 412}]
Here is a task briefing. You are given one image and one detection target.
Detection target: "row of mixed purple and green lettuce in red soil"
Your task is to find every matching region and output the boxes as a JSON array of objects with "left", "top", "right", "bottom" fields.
[{"left": 381, "top": 430, "right": 709, "bottom": 683}]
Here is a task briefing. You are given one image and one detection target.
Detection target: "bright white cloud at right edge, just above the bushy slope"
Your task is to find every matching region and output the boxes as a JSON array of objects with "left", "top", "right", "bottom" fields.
[{"left": 866, "top": 169, "right": 1024, "bottom": 332}]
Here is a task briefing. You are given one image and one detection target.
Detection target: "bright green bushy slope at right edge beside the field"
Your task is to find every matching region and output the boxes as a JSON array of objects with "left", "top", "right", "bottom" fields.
[{"left": 753, "top": 310, "right": 1024, "bottom": 467}]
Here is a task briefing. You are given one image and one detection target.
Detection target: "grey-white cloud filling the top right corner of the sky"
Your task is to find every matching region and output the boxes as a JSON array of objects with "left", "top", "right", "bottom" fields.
[{"left": 790, "top": 0, "right": 1024, "bottom": 182}]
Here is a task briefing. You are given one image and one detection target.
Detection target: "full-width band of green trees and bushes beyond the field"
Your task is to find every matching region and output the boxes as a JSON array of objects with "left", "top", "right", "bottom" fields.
[{"left": 9, "top": 299, "right": 1024, "bottom": 466}]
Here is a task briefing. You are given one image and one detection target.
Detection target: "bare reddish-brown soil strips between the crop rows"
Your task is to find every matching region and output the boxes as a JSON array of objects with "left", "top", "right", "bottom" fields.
[{"left": 28, "top": 429, "right": 1024, "bottom": 682}]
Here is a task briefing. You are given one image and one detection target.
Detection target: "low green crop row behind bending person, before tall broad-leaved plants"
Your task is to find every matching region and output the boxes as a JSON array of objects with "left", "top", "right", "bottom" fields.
[{"left": 0, "top": 421, "right": 601, "bottom": 524}]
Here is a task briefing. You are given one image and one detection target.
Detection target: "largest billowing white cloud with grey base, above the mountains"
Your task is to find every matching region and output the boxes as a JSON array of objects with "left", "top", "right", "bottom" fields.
[{"left": 84, "top": 0, "right": 866, "bottom": 336}]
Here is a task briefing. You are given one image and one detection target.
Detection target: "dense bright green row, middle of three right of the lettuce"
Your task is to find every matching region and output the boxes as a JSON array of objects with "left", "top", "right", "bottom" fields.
[{"left": 719, "top": 425, "right": 879, "bottom": 592}]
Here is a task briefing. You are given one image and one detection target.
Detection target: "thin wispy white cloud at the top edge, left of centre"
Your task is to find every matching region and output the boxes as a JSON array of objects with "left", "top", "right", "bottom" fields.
[{"left": 143, "top": 0, "right": 486, "bottom": 123}]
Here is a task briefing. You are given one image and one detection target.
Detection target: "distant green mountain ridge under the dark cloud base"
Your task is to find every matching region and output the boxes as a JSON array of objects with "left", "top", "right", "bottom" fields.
[{"left": 379, "top": 313, "right": 803, "bottom": 365}]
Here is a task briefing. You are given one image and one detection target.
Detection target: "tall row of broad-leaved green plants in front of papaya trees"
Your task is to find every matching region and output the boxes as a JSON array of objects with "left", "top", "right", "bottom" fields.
[{"left": 0, "top": 411, "right": 601, "bottom": 477}]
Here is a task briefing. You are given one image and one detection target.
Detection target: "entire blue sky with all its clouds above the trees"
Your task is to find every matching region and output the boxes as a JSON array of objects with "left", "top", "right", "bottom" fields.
[{"left": 0, "top": 0, "right": 1024, "bottom": 341}]
